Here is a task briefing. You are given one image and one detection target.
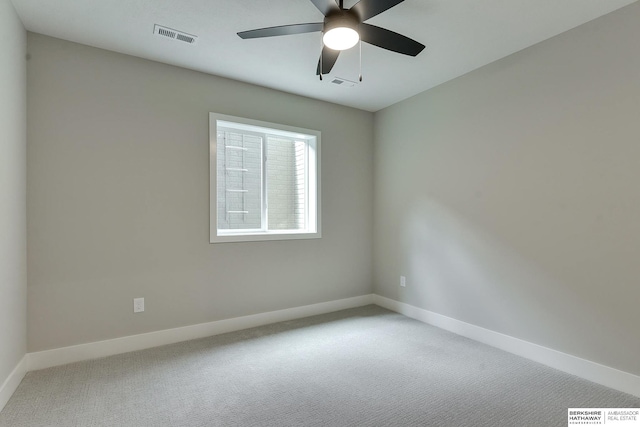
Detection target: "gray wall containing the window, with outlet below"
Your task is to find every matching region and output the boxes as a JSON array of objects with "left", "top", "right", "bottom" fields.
[{"left": 27, "top": 34, "right": 373, "bottom": 351}]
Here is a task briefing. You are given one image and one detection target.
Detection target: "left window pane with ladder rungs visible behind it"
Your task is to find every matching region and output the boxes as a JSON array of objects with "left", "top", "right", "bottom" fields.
[{"left": 217, "top": 129, "right": 262, "bottom": 230}]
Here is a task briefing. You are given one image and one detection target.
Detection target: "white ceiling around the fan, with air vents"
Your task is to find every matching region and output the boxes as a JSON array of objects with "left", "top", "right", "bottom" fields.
[{"left": 12, "top": 0, "right": 637, "bottom": 111}]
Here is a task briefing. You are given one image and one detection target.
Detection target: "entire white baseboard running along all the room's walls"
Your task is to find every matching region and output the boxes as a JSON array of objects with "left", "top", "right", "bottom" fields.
[{"left": 20, "top": 294, "right": 640, "bottom": 402}]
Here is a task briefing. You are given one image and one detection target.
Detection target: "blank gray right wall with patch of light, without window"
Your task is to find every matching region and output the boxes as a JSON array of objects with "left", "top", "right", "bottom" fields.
[{"left": 374, "top": 3, "right": 640, "bottom": 375}]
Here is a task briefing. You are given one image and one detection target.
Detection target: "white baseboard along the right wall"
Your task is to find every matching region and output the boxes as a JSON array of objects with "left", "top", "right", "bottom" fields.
[{"left": 373, "top": 295, "right": 640, "bottom": 397}]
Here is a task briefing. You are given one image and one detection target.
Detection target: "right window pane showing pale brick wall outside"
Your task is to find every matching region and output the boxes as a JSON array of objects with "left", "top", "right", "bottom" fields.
[{"left": 267, "top": 136, "right": 307, "bottom": 230}]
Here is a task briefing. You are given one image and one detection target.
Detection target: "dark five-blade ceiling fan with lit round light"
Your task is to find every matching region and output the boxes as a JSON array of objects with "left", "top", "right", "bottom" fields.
[{"left": 238, "top": 0, "right": 425, "bottom": 80}]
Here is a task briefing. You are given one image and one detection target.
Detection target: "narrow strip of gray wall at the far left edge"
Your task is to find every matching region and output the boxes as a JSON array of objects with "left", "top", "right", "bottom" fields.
[{"left": 0, "top": 0, "right": 27, "bottom": 386}]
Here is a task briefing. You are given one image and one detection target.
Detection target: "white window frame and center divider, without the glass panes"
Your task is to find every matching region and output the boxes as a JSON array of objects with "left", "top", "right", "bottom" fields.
[{"left": 209, "top": 113, "right": 322, "bottom": 243}]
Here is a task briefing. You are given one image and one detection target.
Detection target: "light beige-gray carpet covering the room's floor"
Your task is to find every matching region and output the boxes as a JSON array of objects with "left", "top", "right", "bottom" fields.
[{"left": 0, "top": 306, "right": 640, "bottom": 427}]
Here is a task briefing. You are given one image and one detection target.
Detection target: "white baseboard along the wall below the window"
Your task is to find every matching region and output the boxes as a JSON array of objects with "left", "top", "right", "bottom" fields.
[{"left": 27, "top": 295, "right": 373, "bottom": 371}]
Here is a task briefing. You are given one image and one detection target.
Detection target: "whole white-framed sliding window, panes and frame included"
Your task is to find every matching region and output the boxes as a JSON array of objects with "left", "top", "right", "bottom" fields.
[{"left": 209, "top": 113, "right": 320, "bottom": 243}]
